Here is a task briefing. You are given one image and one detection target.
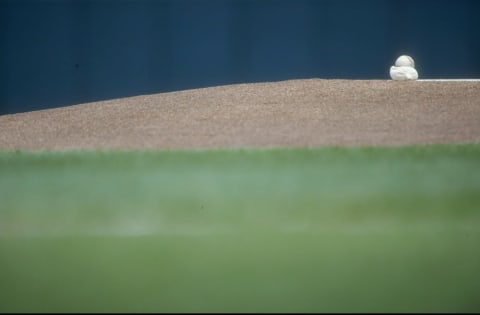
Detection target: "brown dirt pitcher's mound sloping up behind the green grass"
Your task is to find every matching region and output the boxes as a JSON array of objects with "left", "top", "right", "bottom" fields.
[{"left": 0, "top": 79, "right": 480, "bottom": 150}]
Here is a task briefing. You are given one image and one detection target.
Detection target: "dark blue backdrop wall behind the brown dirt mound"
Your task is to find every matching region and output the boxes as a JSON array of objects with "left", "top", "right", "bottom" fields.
[{"left": 0, "top": 0, "right": 480, "bottom": 114}]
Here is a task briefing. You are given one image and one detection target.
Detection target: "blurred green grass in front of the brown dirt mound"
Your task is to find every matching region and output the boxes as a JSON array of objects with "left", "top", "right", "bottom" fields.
[{"left": 0, "top": 144, "right": 480, "bottom": 312}]
